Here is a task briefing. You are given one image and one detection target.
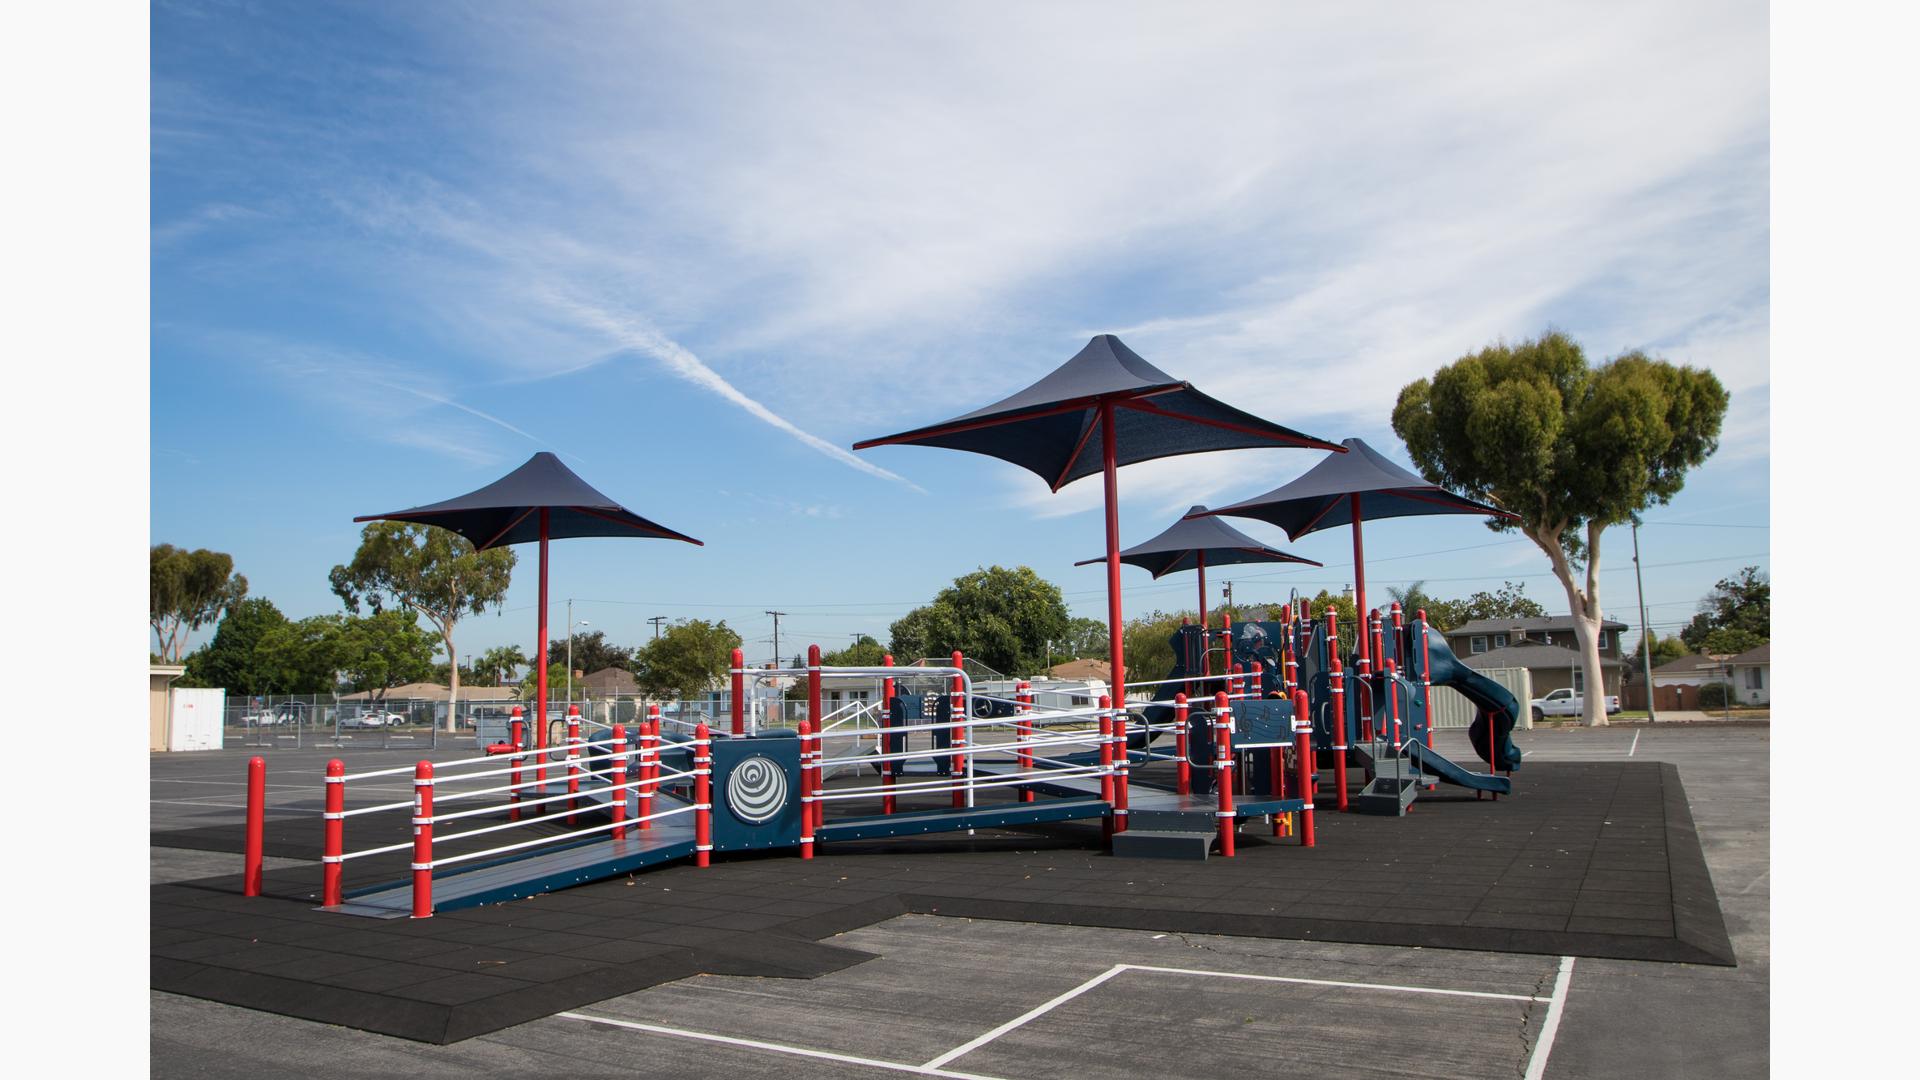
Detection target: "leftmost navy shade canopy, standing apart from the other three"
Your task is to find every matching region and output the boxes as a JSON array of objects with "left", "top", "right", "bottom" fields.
[{"left": 353, "top": 450, "right": 701, "bottom": 552}]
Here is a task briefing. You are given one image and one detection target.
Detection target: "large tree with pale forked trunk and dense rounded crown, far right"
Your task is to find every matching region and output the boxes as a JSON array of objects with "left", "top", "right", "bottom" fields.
[{"left": 1394, "top": 332, "right": 1726, "bottom": 726}]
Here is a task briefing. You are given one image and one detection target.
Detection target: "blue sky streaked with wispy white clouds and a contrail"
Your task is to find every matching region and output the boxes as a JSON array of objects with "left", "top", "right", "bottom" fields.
[{"left": 150, "top": 2, "right": 1770, "bottom": 657}]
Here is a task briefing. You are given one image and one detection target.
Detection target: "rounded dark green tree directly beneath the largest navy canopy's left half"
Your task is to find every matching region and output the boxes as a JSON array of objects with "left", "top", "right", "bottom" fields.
[{"left": 889, "top": 567, "right": 1069, "bottom": 675}]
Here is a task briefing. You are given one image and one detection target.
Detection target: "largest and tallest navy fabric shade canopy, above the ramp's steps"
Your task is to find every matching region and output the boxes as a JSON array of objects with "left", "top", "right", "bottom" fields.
[{"left": 854, "top": 334, "right": 1340, "bottom": 492}]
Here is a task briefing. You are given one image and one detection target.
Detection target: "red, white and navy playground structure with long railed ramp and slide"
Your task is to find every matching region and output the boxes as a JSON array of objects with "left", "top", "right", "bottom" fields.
[{"left": 248, "top": 605, "right": 1519, "bottom": 917}]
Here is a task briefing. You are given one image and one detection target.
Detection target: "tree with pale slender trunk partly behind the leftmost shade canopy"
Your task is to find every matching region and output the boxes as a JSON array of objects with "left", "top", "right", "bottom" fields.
[{"left": 326, "top": 521, "right": 516, "bottom": 730}]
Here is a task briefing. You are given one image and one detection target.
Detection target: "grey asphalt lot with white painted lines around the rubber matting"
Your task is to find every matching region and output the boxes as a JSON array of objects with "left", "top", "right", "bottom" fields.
[{"left": 152, "top": 724, "right": 1768, "bottom": 1078}]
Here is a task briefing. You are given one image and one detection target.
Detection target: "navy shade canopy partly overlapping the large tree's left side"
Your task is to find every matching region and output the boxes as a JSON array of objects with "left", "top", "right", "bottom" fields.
[{"left": 1188, "top": 438, "right": 1513, "bottom": 540}]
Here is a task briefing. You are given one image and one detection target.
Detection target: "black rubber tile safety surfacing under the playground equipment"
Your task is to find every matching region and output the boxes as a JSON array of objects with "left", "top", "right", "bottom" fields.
[{"left": 152, "top": 761, "right": 1734, "bottom": 1043}]
